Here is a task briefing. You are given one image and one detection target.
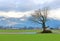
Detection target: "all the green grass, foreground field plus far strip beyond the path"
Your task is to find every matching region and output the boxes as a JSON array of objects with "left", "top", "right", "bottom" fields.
[{"left": 0, "top": 30, "right": 60, "bottom": 41}]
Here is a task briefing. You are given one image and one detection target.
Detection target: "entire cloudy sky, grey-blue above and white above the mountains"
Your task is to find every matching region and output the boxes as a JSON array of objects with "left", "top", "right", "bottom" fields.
[{"left": 0, "top": 0, "right": 60, "bottom": 19}]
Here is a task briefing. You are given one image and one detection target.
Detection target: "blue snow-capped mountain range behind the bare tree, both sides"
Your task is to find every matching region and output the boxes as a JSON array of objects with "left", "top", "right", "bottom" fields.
[{"left": 0, "top": 16, "right": 60, "bottom": 27}]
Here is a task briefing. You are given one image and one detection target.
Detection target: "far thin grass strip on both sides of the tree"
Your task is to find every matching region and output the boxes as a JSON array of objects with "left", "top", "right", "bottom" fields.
[{"left": 0, "top": 29, "right": 60, "bottom": 34}]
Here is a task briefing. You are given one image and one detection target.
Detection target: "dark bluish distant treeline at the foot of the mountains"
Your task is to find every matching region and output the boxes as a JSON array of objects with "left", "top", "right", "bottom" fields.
[{"left": 0, "top": 26, "right": 60, "bottom": 30}]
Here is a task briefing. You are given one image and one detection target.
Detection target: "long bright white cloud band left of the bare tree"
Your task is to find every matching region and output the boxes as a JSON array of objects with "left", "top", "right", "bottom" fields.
[{"left": 0, "top": 11, "right": 32, "bottom": 18}]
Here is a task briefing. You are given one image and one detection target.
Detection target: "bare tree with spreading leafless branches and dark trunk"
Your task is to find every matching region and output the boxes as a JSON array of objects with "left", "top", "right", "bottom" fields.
[{"left": 31, "top": 8, "right": 48, "bottom": 31}]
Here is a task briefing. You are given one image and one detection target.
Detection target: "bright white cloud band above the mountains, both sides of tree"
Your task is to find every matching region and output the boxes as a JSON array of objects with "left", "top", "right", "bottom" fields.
[{"left": 0, "top": 8, "right": 60, "bottom": 21}]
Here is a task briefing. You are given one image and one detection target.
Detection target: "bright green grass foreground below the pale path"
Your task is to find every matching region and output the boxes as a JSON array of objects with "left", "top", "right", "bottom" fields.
[{"left": 0, "top": 34, "right": 60, "bottom": 41}]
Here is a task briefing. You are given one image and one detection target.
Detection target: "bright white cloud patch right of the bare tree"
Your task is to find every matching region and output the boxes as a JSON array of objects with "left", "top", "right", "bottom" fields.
[{"left": 48, "top": 8, "right": 60, "bottom": 20}]
